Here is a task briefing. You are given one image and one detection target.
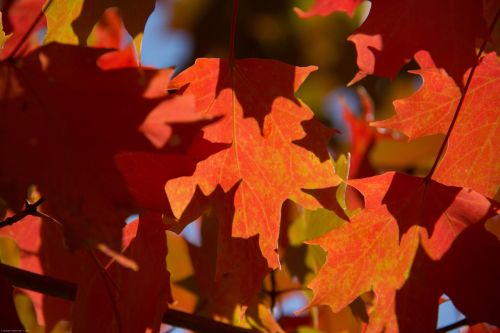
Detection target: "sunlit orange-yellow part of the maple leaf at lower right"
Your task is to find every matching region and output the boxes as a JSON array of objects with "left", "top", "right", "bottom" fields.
[{"left": 307, "top": 204, "right": 418, "bottom": 332}]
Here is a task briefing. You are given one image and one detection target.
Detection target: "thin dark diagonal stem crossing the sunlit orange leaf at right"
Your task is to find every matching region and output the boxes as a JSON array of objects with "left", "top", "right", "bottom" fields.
[{"left": 425, "top": 9, "right": 500, "bottom": 180}]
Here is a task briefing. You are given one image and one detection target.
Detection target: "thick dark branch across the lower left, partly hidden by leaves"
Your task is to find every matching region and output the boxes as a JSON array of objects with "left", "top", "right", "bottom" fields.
[{"left": 0, "top": 263, "right": 255, "bottom": 333}]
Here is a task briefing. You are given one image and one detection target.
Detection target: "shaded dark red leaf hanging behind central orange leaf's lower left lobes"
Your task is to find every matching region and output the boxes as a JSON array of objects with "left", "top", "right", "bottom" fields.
[{"left": 189, "top": 188, "right": 270, "bottom": 319}]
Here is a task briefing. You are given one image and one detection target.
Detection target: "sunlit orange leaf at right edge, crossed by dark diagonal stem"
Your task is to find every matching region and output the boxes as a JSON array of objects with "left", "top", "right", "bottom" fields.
[{"left": 373, "top": 53, "right": 500, "bottom": 198}]
